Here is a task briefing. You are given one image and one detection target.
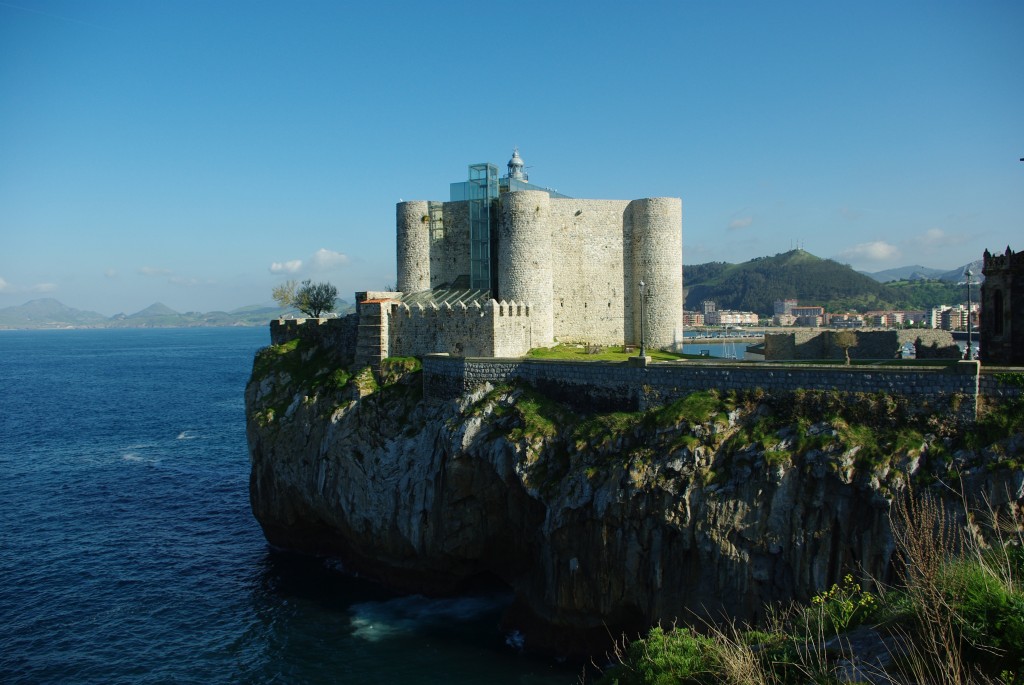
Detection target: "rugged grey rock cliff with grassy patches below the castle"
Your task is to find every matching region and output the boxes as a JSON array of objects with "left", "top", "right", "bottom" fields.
[{"left": 246, "top": 346, "right": 1024, "bottom": 651}]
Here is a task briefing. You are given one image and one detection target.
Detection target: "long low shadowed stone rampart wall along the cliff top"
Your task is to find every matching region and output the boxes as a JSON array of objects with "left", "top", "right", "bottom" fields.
[{"left": 423, "top": 355, "right": 978, "bottom": 421}]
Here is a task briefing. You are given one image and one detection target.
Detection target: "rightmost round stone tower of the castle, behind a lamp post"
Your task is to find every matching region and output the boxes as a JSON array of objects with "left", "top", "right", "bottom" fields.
[{"left": 630, "top": 198, "right": 683, "bottom": 348}]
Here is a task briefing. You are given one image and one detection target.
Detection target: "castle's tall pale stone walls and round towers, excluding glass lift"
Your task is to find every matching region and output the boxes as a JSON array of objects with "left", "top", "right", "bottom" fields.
[{"left": 397, "top": 190, "right": 682, "bottom": 347}]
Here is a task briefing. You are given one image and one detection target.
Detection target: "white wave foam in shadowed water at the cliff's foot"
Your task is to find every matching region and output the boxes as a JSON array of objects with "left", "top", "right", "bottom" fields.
[{"left": 349, "top": 595, "right": 509, "bottom": 642}]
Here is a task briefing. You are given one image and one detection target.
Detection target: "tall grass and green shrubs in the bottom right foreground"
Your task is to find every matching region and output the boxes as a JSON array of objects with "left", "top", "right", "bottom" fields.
[{"left": 598, "top": 491, "right": 1024, "bottom": 685}]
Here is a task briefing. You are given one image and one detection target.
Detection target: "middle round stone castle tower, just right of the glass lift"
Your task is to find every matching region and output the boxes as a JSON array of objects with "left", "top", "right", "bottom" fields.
[{"left": 498, "top": 190, "right": 554, "bottom": 347}]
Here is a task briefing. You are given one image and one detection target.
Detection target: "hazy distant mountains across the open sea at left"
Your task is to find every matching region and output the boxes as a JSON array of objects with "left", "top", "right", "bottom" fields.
[{"left": 0, "top": 298, "right": 351, "bottom": 329}]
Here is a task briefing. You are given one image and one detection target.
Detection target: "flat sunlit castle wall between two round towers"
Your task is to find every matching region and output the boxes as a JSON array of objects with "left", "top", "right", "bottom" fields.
[{"left": 549, "top": 199, "right": 632, "bottom": 345}]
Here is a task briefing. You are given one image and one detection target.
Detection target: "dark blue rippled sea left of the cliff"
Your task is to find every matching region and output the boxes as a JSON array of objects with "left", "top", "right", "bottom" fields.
[{"left": 0, "top": 328, "right": 579, "bottom": 685}]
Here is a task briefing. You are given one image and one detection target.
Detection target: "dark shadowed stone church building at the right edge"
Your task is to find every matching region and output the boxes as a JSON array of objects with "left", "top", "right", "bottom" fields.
[{"left": 978, "top": 247, "right": 1024, "bottom": 366}]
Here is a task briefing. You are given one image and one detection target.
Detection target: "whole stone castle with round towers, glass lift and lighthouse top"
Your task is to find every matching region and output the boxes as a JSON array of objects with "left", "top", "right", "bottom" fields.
[{"left": 355, "top": 151, "right": 683, "bottom": 366}]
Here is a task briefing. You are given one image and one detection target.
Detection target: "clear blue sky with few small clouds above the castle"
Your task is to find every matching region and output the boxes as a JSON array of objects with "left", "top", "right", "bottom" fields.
[{"left": 0, "top": 0, "right": 1024, "bottom": 314}]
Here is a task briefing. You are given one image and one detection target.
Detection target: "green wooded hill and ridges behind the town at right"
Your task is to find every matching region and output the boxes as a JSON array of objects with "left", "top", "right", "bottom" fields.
[{"left": 683, "top": 250, "right": 981, "bottom": 315}]
